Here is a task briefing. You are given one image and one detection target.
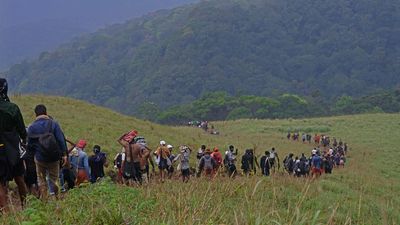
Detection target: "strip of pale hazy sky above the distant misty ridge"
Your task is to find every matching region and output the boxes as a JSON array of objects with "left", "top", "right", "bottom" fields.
[{"left": 0, "top": 0, "right": 196, "bottom": 28}]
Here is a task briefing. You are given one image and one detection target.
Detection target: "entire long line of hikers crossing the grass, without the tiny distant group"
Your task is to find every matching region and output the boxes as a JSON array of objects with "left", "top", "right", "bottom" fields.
[{"left": 0, "top": 79, "right": 347, "bottom": 211}]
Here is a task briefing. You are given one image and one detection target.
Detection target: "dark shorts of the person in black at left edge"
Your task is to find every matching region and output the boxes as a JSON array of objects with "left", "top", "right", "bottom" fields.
[{"left": 0, "top": 152, "right": 25, "bottom": 185}]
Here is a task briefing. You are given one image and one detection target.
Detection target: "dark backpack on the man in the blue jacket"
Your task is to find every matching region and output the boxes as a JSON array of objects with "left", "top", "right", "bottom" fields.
[{"left": 30, "top": 120, "right": 62, "bottom": 162}]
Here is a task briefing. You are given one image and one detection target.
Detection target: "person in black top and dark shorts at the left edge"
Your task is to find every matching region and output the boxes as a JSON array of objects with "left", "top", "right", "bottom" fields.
[{"left": 0, "top": 78, "right": 27, "bottom": 212}]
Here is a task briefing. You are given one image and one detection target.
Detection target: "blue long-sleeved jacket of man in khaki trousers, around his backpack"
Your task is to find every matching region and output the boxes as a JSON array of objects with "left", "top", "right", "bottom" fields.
[{"left": 28, "top": 117, "right": 68, "bottom": 162}]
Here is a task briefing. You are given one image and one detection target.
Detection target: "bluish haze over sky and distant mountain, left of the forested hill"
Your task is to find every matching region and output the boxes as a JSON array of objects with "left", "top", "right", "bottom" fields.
[{"left": 0, "top": 0, "right": 196, "bottom": 69}]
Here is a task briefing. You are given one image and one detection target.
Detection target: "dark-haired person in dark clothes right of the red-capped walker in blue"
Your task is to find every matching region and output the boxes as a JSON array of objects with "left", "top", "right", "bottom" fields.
[{"left": 89, "top": 145, "right": 108, "bottom": 183}]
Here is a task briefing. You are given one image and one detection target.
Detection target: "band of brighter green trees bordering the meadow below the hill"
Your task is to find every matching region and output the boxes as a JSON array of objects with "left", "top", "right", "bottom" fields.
[{"left": 148, "top": 89, "right": 400, "bottom": 124}]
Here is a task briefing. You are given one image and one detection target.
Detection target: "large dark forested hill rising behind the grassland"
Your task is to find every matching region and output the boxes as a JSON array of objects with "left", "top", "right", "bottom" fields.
[{"left": 6, "top": 0, "right": 400, "bottom": 113}]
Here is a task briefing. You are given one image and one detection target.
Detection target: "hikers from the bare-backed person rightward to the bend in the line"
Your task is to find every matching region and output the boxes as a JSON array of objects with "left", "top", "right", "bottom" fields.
[{"left": 114, "top": 130, "right": 346, "bottom": 186}]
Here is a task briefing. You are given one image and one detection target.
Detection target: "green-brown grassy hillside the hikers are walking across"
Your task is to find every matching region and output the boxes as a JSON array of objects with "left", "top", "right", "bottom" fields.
[{"left": 0, "top": 96, "right": 400, "bottom": 224}]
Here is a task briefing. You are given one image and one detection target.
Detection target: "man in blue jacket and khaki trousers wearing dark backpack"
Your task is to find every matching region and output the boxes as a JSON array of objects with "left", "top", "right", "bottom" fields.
[{"left": 28, "top": 105, "right": 68, "bottom": 199}]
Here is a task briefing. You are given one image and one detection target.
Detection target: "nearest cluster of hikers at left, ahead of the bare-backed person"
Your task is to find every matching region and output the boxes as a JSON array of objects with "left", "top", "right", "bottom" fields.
[{"left": 0, "top": 78, "right": 107, "bottom": 212}]
